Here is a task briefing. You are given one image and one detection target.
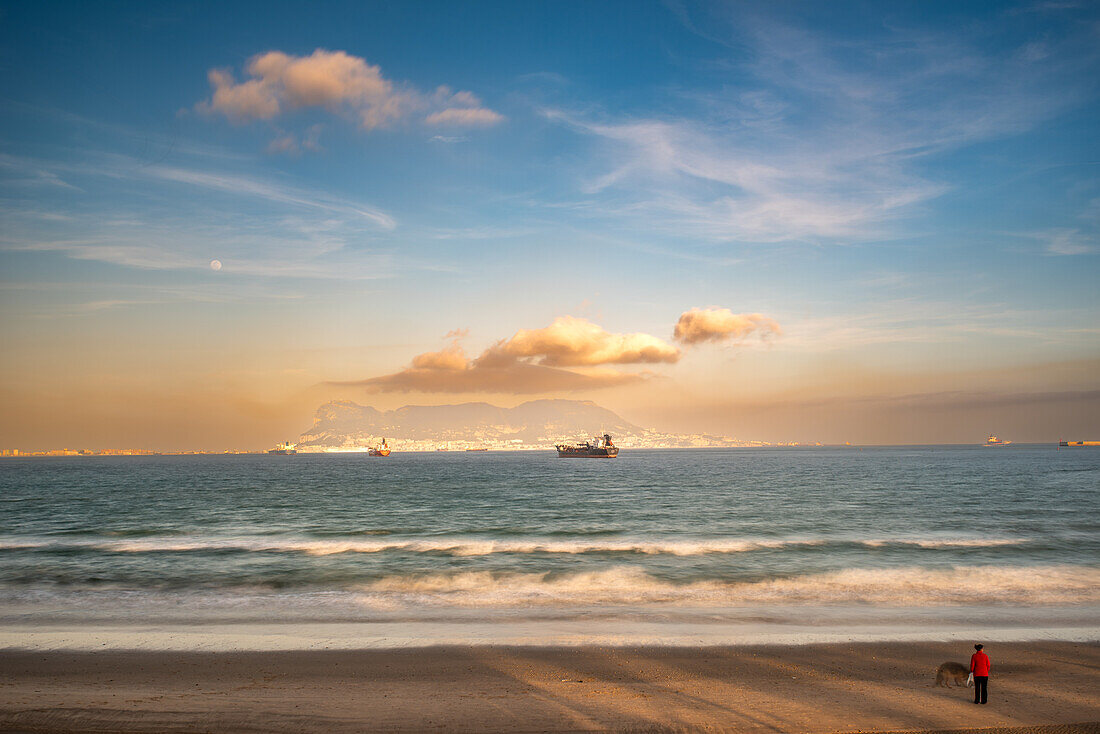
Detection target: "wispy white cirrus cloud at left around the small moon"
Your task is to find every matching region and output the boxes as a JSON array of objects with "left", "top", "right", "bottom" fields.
[{"left": 0, "top": 154, "right": 400, "bottom": 280}]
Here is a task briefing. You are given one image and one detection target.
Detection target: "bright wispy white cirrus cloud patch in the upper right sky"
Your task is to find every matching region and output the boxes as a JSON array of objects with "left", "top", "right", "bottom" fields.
[{"left": 548, "top": 105, "right": 946, "bottom": 242}]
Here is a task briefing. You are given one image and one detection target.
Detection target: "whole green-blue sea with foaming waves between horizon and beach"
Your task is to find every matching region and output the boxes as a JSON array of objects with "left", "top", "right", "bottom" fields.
[{"left": 0, "top": 446, "right": 1100, "bottom": 649}]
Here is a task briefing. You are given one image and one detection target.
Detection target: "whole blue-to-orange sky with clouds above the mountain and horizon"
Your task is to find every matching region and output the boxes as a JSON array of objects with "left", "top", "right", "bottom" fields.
[{"left": 0, "top": 0, "right": 1100, "bottom": 450}]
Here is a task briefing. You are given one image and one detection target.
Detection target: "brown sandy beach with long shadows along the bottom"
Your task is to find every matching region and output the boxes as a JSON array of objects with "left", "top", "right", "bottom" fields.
[{"left": 0, "top": 642, "right": 1100, "bottom": 732}]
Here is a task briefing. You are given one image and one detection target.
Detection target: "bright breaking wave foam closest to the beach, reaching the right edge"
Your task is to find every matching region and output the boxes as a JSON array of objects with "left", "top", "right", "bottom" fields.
[{"left": 349, "top": 566, "right": 1100, "bottom": 609}]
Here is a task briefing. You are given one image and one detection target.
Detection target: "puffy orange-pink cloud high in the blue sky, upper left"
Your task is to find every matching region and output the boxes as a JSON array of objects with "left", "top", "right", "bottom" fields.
[{"left": 199, "top": 48, "right": 504, "bottom": 130}]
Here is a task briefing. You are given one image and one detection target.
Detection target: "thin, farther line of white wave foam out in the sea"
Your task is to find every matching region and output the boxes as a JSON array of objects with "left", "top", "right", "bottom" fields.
[{"left": 0, "top": 536, "right": 1027, "bottom": 556}]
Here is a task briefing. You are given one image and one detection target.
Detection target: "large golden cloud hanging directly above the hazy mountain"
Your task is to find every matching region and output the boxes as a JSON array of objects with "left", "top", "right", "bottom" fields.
[{"left": 339, "top": 316, "right": 680, "bottom": 393}]
